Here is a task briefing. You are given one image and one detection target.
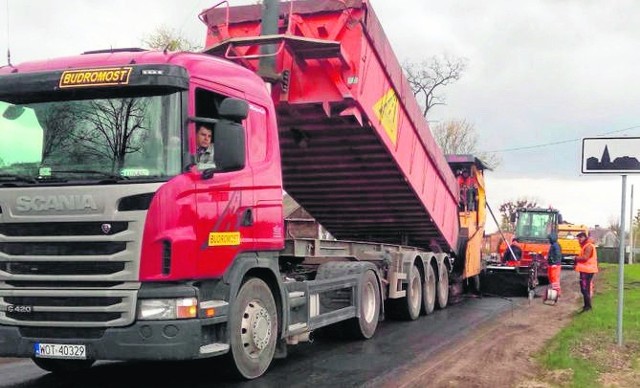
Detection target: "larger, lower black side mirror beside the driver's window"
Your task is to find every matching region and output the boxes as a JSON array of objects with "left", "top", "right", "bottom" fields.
[{"left": 213, "top": 119, "right": 246, "bottom": 171}]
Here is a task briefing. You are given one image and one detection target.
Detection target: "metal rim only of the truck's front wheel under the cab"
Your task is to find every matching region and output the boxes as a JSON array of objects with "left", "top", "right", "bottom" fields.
[{"left": 240, "top": 300, "right": 272, "bottom": 358}]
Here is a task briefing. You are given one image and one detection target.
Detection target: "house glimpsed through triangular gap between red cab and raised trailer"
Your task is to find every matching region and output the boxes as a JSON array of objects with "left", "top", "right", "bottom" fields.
[{"left": 283, "top": 194, "right": 334, "bottom": 240}]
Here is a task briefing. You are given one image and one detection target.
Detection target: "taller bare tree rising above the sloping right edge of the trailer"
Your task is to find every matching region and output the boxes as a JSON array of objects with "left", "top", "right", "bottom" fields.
[{"left": 402, "top": 56, "right": 467, "bottom": 117}]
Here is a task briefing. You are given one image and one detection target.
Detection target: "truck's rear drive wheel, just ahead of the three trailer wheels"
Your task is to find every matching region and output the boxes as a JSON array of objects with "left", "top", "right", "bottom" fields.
[{"left": 345, "top": 271, "right": 380, "bottom": 339}]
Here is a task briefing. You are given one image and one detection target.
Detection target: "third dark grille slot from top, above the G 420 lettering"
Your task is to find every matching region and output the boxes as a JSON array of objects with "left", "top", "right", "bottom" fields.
[{"left": 0, "top": 261, "right": 125, "bottom": 275}]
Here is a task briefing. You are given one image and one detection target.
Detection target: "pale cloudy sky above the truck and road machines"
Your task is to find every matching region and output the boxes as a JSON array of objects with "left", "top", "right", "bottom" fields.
[{"left": 0, "top": 0, "right": 640, "bottom": 231}]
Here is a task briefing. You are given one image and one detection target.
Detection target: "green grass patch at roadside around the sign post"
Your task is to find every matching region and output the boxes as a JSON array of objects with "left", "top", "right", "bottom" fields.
[{"left": 536, "top": 263, "right": 640, "bottom": 388}]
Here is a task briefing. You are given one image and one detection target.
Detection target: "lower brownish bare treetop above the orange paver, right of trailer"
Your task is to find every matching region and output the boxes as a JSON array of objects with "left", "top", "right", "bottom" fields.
[{"left": 432, "top": 120, "right": 501, "bottom": 168}]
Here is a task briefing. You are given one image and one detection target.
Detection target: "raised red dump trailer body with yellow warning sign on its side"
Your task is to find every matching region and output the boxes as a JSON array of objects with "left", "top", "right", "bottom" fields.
[{"left": 201, "top": 0, "right": 459, "bottom": 251}]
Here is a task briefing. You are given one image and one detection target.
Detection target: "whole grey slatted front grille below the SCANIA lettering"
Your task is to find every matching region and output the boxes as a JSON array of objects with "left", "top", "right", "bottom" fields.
[{"left": 0, "top": 194, "right": 146, "bottom": 328}]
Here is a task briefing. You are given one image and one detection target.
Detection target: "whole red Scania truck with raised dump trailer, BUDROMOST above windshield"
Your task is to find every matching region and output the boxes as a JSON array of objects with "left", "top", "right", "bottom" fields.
[{"left": 0, "top": 0, "right": 485, "bottom": 379}]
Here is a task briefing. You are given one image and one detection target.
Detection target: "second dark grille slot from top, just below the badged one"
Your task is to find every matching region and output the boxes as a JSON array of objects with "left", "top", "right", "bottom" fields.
[{"left": 0, "top": 241, "right": 127, "bottom": 256}]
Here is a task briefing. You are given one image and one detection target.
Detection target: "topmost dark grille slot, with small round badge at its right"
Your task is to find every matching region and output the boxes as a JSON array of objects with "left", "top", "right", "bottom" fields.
[{"left": 0, "top": 221, "right": 129, "bottom": 236}]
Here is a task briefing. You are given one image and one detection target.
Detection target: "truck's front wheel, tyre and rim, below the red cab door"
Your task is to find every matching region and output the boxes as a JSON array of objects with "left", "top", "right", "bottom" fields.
[{"left": 228, "top": 278, "right": 278, "bottom": 379}]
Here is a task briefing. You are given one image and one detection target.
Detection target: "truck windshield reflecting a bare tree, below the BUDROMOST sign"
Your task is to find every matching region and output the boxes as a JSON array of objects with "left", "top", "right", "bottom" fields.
[{"left": 0, "top": 92, "right": 181, "bottom": 184}]
